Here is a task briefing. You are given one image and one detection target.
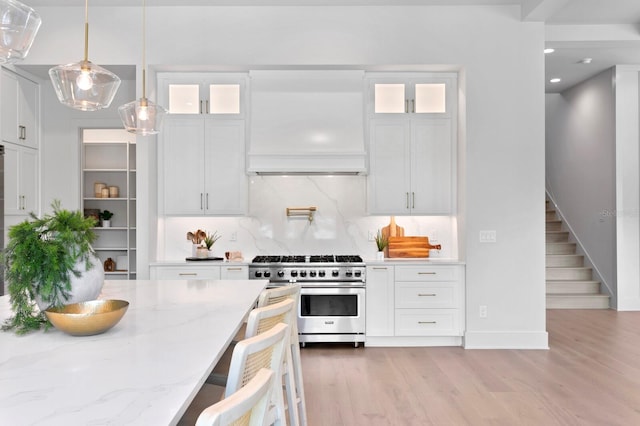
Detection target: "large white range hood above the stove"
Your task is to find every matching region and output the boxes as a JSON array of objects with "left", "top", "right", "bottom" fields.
[{"left": 247, "top": 70, "right": 366, "bottom": 174}]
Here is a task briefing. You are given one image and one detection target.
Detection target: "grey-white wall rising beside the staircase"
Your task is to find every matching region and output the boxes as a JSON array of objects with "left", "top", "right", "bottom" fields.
[{"left": 546, "top": 69, "right": 616, "bottom": 300}]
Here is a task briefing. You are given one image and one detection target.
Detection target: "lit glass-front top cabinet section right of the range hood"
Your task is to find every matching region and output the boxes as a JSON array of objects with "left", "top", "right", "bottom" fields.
[{"left": 367, "top": 73, "right": 455, "bottom": 118}]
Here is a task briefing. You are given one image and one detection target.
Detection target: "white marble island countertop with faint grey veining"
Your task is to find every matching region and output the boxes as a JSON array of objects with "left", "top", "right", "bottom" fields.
[{"left": 0, "top": 280, "right": 267, "bottom": 426}]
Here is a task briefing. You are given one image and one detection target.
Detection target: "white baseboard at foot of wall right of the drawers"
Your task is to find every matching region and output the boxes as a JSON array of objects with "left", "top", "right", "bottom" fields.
[{"left": 464, "top": 331, "right": 549, "bottom": 349}]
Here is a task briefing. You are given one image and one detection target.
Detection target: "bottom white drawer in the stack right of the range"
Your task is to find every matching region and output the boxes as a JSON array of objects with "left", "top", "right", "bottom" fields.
[{"left": 395, "top": 309, "right": 462, "bottom": 336}]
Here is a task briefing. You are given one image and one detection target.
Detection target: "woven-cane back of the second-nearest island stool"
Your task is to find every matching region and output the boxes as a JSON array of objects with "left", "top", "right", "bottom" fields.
[{"left": 225, "top": 323, "right": 290, "bottom": 397}]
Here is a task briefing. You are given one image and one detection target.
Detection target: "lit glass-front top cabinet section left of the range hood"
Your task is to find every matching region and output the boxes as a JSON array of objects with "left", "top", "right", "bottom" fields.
[{"left": 158, "top": 73, "right": 247, "bottom": 119}]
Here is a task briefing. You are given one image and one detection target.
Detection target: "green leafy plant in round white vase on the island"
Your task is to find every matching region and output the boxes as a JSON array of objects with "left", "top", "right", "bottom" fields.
[{"left": 2, "top": 201, "right": 104, "bottom": 334}]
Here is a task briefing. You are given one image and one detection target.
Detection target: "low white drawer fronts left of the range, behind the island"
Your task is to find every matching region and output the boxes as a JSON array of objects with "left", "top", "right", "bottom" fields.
[{"left": 150, "top": 261, "right": 249, "bottom": 280}]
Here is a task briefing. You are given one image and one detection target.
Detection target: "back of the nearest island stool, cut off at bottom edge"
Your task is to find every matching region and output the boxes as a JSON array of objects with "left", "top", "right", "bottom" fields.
[{"left": 196, "top": 368, "right": 275, "bottom": 426}]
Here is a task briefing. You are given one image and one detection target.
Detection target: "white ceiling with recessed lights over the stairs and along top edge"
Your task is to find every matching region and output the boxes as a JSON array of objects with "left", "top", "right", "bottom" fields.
[{"left": 23, "top": 0, "right": 640, "bottom": 93}]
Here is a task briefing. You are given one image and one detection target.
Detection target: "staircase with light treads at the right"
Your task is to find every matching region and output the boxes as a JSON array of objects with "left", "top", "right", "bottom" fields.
[{"left": 546, "top": 201, "right": 609, "bottom": 309}]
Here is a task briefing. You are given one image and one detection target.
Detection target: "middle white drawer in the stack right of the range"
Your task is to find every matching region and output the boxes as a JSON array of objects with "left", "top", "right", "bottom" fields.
[{"left": 395, "top": 281, "right": 459, "bottom": 308}]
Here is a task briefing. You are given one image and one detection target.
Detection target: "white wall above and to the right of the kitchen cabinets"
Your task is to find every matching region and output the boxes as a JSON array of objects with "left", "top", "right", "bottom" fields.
[{"left": 22, "top": 6, "right": 547, "bottom": 348}]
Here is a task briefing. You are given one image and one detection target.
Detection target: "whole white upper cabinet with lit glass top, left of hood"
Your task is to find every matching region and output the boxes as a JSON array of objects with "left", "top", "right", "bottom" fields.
[{"left": 158, "top": 73, "right": 248, "bottom": 216}]
